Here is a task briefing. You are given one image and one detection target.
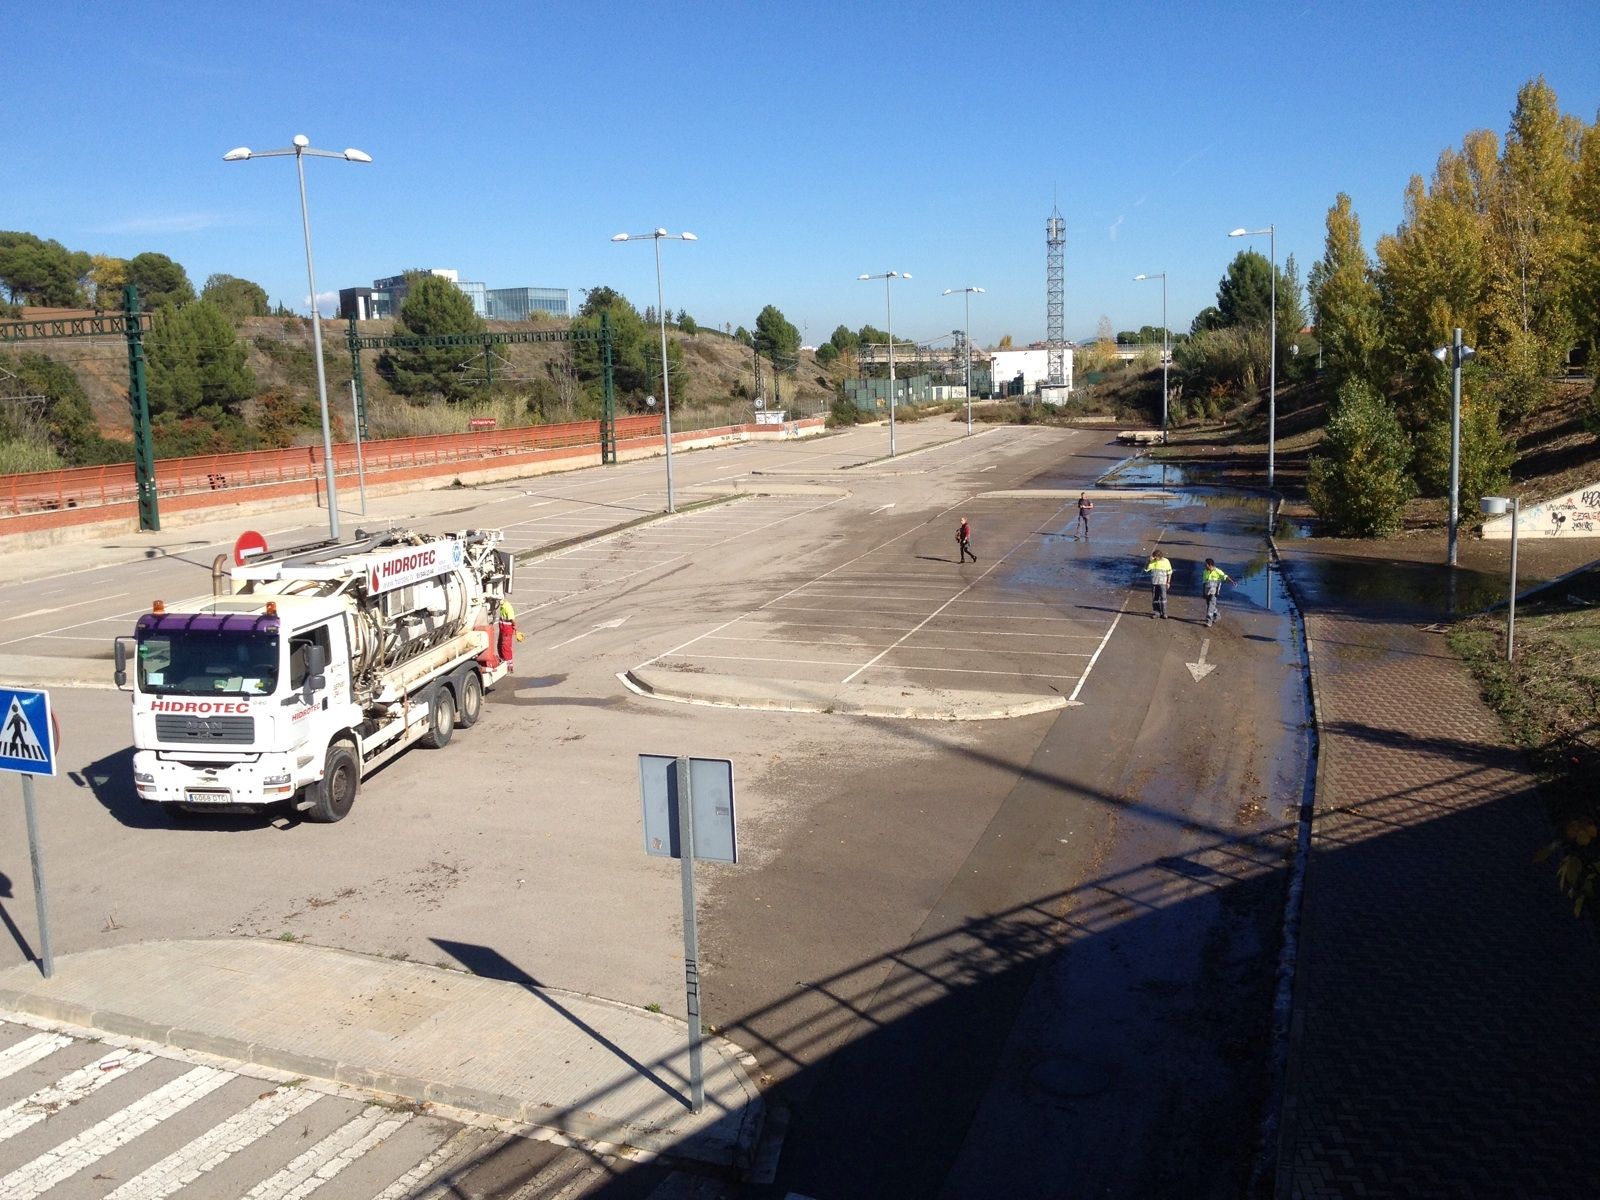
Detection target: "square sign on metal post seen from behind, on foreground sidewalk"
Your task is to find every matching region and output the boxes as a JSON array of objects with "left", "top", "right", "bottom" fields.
[{"left": 638, "top": 754, "right": 739, "bottom": 1112}]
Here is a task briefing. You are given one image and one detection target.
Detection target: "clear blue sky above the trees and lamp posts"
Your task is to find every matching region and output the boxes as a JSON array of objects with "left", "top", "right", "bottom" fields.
[{"left": 0, "top": 0, "right": 1600, "bottom": 344}]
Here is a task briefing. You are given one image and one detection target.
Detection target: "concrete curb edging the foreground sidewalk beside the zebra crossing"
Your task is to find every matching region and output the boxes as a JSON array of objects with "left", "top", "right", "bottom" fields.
[{"left": 0, "top": 947, "right": 765, "bottom": 1173}]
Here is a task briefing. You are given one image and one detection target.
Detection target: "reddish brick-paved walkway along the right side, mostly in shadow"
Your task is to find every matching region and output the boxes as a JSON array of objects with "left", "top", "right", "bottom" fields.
[{"left": 1275, "top": 546, "right": 1600, "bottom": 1200}]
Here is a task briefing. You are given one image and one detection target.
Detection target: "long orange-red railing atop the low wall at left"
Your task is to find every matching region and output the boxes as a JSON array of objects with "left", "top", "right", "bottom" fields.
[{"left": 0, "top": 416, "right": 661, "bottom": 515}]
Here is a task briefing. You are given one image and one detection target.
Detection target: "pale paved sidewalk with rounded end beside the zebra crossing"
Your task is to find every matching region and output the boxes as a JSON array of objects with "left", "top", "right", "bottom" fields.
[{"left": 0, "top": 938, "right": 763, "bottom": 1168}]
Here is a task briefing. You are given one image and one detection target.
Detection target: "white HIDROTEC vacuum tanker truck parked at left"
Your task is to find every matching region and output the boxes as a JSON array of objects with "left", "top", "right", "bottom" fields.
[{"left": 115, "top": 530, "right": 515, "bottom": 821}]
